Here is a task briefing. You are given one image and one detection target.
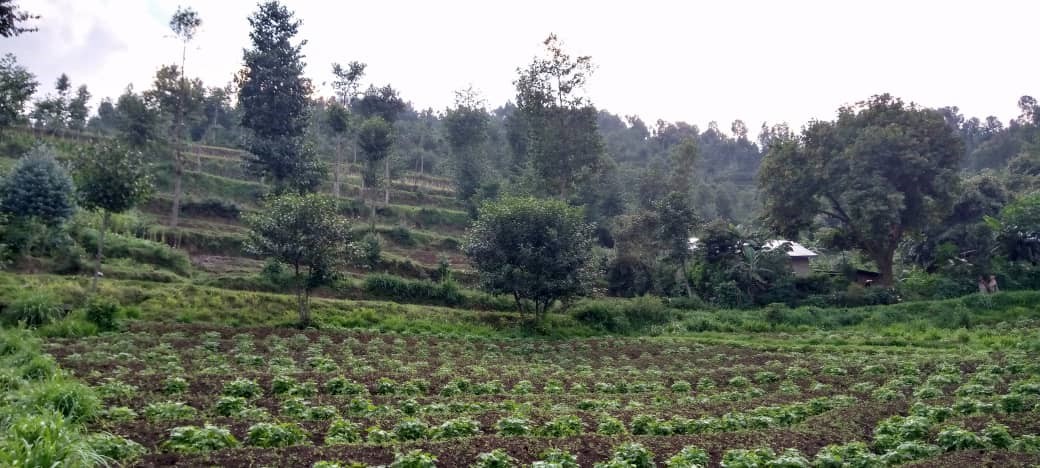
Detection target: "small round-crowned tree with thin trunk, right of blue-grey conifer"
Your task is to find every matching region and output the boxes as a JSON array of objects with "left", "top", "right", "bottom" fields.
[{"left": 74, "top": 141, "right": 152, "bottom": 291}]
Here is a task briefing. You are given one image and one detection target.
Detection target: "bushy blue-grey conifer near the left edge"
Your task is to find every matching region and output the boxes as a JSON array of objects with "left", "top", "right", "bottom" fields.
[{"left": 0, "top": 146, "right": 75, "bottom": 227}]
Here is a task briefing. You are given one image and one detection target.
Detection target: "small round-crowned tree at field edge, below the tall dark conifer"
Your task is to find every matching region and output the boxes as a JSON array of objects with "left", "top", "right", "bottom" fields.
[{"left": 245, "top": 193, "right": 349, "bottom": 327}]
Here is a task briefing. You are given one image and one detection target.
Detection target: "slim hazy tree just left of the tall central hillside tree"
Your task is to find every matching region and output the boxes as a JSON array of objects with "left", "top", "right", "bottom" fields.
[{"left": 442, "top": 87, "right": 491, "bottom": 201}]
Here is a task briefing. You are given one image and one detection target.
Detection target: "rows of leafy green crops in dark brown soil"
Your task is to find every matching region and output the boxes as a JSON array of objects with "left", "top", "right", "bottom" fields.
[{"left": 42, "top": 326, "right": 1040, "bottom": 466}]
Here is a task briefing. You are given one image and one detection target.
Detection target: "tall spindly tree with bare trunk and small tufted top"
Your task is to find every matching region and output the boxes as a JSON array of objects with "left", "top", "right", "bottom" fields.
[{"left": 165, "top": 6, "right": 202, "bottom": 228}]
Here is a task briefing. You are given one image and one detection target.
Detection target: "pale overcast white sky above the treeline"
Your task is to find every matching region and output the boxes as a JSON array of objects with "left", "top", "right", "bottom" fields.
[{"left": 8, "top": 0, "right": 1040, "bottom": 133}]
